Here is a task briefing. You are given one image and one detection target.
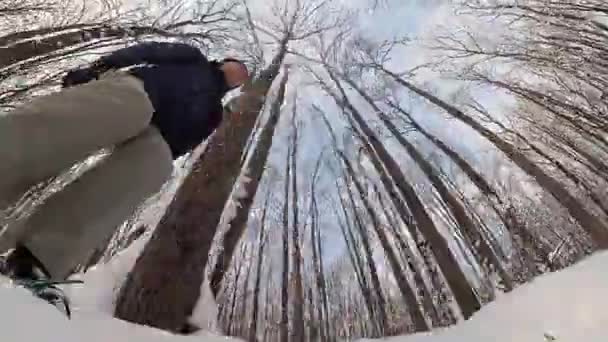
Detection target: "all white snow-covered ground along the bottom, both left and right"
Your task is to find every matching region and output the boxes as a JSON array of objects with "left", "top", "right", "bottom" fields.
[{"left": 0, "top": 240, "right": 608, "bottom": 342}]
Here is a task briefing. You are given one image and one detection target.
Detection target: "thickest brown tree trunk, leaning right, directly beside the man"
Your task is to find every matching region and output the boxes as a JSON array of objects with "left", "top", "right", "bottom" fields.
[{"left": 115, "top": 39, "right": 288, "bottom": 331}]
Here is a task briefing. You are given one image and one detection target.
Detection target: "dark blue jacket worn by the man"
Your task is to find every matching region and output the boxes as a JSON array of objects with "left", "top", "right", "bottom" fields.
[{"left": 64, "top": 42, "right": 229, "bottom": 158}]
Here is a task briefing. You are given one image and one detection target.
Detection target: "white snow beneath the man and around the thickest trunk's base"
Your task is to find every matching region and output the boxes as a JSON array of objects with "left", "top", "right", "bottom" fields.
[{"left": 0, "top": 238, "right": 239, "bottom": 342}]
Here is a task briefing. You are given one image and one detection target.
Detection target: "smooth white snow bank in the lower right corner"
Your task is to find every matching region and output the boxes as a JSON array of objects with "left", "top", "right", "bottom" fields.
[{"left": 364, "top": 252, "right": 608, "bottom": 342}]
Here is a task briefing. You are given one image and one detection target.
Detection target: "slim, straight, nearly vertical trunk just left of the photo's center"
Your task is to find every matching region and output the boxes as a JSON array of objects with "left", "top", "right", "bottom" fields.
[{"left": 291, "top": 103, "right": 305, "bottom": 342}]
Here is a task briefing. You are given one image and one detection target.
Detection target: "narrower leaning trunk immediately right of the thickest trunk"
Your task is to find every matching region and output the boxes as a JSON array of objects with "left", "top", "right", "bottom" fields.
[{"left": 210, "top": 70, "right": 288, "bottom": 296}]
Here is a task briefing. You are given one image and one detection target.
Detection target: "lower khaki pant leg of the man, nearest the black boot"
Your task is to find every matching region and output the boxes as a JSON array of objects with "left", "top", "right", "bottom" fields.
[{"left": 20, "top": 127, "right": 173, "bottom": 279}]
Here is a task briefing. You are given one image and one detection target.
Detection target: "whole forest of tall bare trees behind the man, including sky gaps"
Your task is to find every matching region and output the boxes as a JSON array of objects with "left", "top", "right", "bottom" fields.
[{"left": 0, "top": 0, "right": 608, "bottom": 342}]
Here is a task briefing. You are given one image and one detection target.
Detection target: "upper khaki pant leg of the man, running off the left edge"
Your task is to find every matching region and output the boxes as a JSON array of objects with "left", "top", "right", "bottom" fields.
[{"left": 0, "top": 73, "right": 154, "bottom": 210}]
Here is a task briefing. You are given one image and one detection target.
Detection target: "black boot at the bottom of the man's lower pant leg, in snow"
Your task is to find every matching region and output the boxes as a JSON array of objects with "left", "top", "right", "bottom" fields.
[{"left": 0, "top": 245, "right": 76, "bottom": 318}]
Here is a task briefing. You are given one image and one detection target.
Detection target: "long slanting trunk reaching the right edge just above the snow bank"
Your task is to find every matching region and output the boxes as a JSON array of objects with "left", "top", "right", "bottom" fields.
[{"left": 381, "top": 67, "right": 608, "bottom": 249}]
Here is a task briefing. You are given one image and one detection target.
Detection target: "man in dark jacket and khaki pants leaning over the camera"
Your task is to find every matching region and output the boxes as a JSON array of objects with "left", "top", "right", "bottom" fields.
[{"left": 0, "top": 42, "right": 249, "bottom": 312}]
